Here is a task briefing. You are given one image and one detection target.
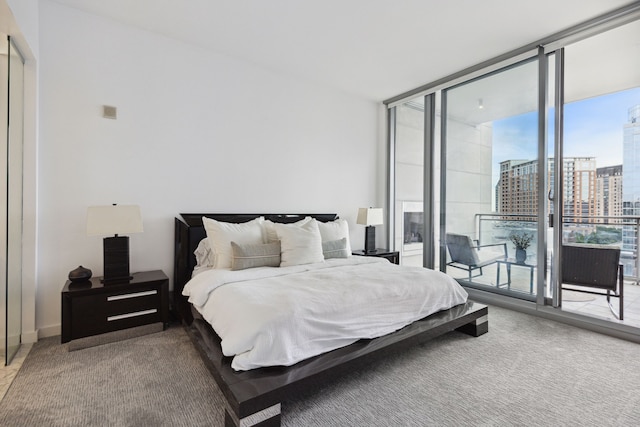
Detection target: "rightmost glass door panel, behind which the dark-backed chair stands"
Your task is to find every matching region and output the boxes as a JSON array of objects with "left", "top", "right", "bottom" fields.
[{"left": 554, "top": 21, "right": 640, "bottom": 327}]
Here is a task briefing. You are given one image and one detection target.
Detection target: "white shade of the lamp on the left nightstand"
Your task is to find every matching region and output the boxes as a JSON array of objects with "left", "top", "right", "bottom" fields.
[{"left": 87, "top": 205, "right": 142, "bottom": 236}]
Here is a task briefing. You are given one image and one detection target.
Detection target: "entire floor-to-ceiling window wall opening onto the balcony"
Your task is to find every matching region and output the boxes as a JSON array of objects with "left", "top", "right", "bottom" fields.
[{"left": 388, "top": 1, "right": 640, "bottom": 340}]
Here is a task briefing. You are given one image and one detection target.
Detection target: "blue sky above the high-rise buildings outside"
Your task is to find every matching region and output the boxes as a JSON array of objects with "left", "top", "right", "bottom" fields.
[{"left": 493, "top": 88, "right": 640, "bottom": 184}]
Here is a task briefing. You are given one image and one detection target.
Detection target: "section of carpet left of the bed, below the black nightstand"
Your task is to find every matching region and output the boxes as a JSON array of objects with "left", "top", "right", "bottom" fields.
[{"left": 0, "top": 326, "right": 223, "bottom": 427}]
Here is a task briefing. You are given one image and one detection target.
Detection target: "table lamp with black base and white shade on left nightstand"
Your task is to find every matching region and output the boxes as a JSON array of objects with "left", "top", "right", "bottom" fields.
[{"left": 87, "top": 204, "right": 142, "bottom": 284}]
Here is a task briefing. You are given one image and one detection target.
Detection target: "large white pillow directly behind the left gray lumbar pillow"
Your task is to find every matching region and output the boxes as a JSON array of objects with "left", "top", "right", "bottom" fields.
[{"left": 202, "top": 217, "right": 264, "bottom": 268}]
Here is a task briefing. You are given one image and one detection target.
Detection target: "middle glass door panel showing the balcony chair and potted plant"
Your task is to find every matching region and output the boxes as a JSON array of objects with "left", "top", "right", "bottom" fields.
[{"left": 440, "top": 59, "right": 547, "bottom": 300}]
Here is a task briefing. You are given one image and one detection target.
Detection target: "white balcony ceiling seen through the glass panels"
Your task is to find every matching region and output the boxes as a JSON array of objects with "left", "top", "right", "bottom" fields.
[{"left": 424, "top": 20, "right": 640, "bottom": 124}]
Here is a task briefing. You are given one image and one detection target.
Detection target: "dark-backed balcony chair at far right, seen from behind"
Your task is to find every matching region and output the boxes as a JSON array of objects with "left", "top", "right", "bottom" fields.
[{"left": 560, "top": 245, "right": 624, "bottom": 320}]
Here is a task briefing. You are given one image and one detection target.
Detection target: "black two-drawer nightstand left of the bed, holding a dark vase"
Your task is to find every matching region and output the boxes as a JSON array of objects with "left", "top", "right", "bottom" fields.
[{"left": 61, "top": 270, "right": 169, "bottom": 343}]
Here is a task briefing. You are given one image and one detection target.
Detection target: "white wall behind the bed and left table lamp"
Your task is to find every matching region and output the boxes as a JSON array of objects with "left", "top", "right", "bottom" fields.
[{"left": 36, "top": 0, "right": 384, "bottom": 336}]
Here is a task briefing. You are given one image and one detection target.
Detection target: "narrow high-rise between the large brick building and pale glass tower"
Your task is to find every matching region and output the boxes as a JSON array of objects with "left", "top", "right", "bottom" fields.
[{"left": 596, "top": 165, "right": 623, "bottom": 224}]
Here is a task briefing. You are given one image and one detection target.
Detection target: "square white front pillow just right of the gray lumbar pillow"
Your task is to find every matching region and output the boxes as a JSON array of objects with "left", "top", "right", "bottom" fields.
[{"left": 273, "top": 218, "right": 324, "bottom": 267}]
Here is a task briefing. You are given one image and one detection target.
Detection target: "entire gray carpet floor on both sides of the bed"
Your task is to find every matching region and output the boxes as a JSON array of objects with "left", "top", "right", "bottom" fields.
[{"left": 0, "top": 307, "right": 640, "bottom": 426}]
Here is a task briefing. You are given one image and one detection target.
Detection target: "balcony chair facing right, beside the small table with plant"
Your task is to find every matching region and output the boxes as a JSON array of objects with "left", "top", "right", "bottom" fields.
[{"left": 446, "top": 233, "right": 507, "bottom": 281}]
